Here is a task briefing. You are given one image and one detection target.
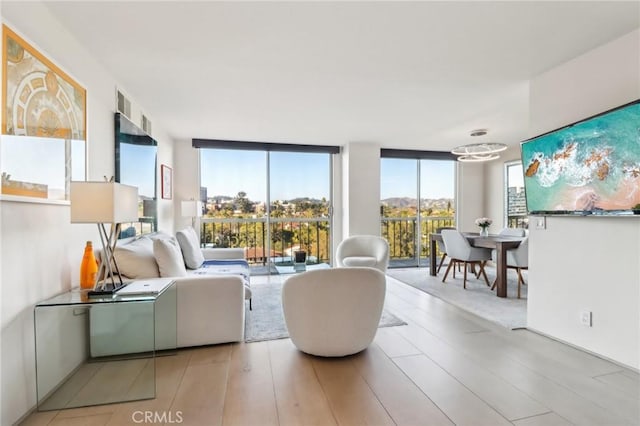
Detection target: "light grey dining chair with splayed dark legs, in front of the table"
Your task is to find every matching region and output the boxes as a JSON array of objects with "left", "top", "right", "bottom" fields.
[{"left": 442, "top": 229, "right": 491, "bottom": 289}]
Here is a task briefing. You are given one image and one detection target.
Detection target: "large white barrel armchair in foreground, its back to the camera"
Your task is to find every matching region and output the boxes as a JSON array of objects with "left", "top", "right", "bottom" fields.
[{"left": 282, "top": 267, "right": 386, "bottom": 357}]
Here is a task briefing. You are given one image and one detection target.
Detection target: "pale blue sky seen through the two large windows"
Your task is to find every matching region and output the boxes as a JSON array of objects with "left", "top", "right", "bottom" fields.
[{"left": 200, "top": 149, "right": 455, "bottom": 201}]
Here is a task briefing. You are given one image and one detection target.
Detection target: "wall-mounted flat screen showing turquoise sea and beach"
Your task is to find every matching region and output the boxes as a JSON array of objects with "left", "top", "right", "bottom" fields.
[{"left": 521, "top": 100, "right": 640, "bottom": 215}]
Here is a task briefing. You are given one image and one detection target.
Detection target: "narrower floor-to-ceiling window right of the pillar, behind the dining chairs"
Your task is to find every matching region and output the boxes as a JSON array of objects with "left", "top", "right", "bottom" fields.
[{"left": 380, "top": 150, "right": 456, "bottom": 267}]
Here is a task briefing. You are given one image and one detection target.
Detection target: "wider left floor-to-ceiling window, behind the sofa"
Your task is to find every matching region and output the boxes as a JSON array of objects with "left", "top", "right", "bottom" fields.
[{"left": 200, "top": 141, "right": 337, "bottom": 273}]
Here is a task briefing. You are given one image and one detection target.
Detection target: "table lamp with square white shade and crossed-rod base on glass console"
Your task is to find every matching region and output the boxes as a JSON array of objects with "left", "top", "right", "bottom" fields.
[{"left": 71, "top": 182, "right": 138, "bottom": 296}]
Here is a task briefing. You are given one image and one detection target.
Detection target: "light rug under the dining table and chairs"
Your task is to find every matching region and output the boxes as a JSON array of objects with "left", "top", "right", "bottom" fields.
[{"left": 387, "top": 267, "right": 527, "bottom": 330}]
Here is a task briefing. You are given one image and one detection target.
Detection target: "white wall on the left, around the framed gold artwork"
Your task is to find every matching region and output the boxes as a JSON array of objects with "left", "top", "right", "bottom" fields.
[{"left": 0, "top": 2, "right": 173, "bottom": 425}]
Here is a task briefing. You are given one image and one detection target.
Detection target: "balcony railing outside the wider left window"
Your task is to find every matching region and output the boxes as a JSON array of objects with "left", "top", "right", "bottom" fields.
[{"left": 200, "top": 217, "right": 331, "bottom": 266}]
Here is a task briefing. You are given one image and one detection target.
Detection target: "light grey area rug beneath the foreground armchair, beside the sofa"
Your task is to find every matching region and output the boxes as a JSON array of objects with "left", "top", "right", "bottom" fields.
[{"left": 244, "top": 283, "right": 407, "bottom": 342}]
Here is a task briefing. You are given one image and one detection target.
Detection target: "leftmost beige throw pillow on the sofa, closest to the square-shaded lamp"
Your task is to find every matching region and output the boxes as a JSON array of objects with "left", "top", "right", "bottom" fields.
[{"left": 113, "top": 236, "right": 160, "bottom": 279}]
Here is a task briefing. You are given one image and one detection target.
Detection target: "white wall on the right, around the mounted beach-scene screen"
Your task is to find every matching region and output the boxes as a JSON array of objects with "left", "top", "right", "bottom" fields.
[{"left": 527, "top": 30, "right": 640, "bottom": 369}]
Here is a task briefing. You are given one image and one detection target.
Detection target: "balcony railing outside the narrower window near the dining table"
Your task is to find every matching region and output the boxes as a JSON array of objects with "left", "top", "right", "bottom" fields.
[{"left": 380, "top": 216, "right": 455, "bottom": 267}]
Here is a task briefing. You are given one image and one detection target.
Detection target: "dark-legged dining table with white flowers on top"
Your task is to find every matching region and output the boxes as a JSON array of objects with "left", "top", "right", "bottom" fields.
[{"left": 429, "top": 232, "right": 524, "bottom": 297}]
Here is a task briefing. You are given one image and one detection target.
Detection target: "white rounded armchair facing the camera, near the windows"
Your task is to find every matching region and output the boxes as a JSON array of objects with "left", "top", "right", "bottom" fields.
[{"left": 336, "top": 235, "right": 389, "bottom": 273}]
